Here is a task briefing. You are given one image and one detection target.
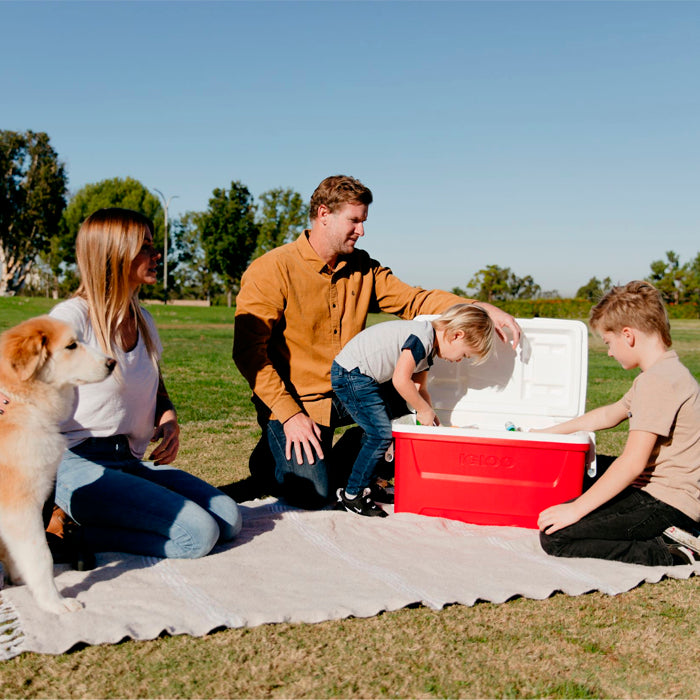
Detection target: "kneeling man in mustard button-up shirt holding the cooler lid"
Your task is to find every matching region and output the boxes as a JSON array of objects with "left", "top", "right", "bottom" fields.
[{"left": 233, "top": 175, "right": 520, "bottom": 508}]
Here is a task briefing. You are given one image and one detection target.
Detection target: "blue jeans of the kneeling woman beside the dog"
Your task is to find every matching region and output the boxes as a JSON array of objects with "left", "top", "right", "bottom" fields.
[{"left": 56, "top": 435, "right": 242, "bottom": 559}]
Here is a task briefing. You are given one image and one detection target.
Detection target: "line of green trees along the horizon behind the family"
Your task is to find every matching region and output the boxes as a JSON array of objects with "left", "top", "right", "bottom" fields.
[{"left": 0, "top": 130, "right": 700, "bottom": 305}]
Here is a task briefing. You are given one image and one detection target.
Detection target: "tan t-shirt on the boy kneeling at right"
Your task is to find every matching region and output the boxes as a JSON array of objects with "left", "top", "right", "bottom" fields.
[{"left": 622, "top": 350, "right": 700, "bottom": 520}]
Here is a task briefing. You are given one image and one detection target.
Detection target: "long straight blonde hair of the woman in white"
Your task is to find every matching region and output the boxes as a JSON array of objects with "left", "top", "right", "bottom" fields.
[{"left": 75, "top": 207, "right": 156, "bottom": 362}]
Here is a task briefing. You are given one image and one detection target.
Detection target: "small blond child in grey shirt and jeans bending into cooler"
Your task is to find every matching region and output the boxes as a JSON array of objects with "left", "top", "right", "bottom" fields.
[{"left": 331, "top": 304, "right": 494, "bottom": 517}]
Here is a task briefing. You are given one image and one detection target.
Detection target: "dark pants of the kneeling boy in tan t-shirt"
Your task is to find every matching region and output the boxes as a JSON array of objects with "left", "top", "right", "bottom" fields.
[{"left": 540, "top": 486, "right": 698, "bottom": 566}]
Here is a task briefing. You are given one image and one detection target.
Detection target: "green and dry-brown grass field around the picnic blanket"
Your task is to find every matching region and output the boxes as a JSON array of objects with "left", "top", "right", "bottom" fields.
[{"left": 0, "top": 298, "right": 700, "bottom": 698}]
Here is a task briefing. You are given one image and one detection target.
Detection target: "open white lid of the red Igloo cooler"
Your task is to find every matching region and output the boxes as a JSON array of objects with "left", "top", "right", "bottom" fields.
[{"left": 421, "top": 316, "right": 588, "bottom": 428}]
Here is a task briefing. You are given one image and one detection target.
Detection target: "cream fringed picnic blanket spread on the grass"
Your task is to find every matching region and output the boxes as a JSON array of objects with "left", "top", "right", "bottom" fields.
[{"left": 0, "top": 499, "right": 700, "bottom": 659}]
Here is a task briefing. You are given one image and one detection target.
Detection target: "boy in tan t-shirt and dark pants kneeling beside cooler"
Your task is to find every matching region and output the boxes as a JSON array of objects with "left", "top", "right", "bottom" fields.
[{"left": 538, "top": 281, "right": 700, "bottom": 566}]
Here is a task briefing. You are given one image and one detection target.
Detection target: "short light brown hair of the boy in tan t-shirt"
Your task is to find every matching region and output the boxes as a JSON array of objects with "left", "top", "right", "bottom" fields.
[{"left": 589, "top": 280, "right": 672, "bottom": 348}]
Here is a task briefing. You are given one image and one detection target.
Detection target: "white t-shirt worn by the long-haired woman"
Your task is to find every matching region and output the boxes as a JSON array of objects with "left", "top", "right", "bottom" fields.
[{"left": 50, "top": 297, "right": 163, "bottom": 459}]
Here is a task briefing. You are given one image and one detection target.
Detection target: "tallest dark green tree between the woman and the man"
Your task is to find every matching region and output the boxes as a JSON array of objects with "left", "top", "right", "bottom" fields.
[{"left": 201, "top": 182, "right": 259, "bottom": 306}]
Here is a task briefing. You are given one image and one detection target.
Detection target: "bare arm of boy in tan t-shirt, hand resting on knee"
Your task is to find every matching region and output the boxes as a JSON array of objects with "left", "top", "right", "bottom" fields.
[{"left": 537, "top": 430, "right": 658, "bottom": 535}]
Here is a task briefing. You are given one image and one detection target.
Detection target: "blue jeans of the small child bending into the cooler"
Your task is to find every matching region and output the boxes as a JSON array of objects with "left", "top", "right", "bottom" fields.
[{"left": 331, "top": 362, "right": 391, "bottom": 494}]
